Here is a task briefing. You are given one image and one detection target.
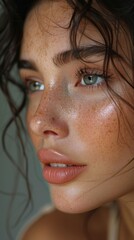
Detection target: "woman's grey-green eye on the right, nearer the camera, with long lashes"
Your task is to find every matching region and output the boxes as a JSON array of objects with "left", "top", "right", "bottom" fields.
[{"left": 81, "top": 74, "right": 105, "bottom": 86}]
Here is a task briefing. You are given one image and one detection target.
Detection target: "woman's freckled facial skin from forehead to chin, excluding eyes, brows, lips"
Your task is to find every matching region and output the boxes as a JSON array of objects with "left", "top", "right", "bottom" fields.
[{"left": 20, "top": 1, "right": 134, "bottom": 213}]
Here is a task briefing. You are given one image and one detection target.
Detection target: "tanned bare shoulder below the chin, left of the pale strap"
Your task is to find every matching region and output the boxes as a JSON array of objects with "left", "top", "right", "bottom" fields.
[{"left": 21, "top": 206, "right": 108, "bottom": 240}]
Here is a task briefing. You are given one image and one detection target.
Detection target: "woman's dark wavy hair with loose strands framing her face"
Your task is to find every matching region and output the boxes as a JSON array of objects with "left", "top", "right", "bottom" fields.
[{"left": 0, "top": 0, "right": 134, "bottom": 238}]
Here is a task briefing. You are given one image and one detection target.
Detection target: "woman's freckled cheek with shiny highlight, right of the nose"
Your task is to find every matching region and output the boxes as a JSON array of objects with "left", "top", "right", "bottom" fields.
[{"left": 71, "top": 99, "right": 134, "bottom": 172}]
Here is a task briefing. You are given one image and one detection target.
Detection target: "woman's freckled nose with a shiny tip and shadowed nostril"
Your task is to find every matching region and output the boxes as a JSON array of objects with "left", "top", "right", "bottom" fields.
[{"left": 30, "top": 90, "right": 69, "bottom": 138}]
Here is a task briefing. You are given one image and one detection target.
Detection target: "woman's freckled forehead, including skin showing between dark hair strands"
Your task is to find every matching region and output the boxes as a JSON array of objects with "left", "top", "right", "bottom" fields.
[{"left": 20, "top": 0, "right": 131, "bottom": 73}]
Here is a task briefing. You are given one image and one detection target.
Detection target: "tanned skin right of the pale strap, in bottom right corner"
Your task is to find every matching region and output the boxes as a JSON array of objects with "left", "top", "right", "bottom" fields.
[{"left": 118, "top": 192, "right": 134, "bottom": 240}]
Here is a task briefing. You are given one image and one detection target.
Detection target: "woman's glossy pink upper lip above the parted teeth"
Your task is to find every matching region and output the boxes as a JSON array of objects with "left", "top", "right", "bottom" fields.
[{"left": 38, "top": 148, "right": 85, "bottom": 166}]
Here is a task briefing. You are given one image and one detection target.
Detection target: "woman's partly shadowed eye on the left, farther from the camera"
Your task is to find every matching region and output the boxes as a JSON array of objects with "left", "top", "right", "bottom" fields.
[{"left": 26, "top": 80, "right": 45, "bottom": 93}]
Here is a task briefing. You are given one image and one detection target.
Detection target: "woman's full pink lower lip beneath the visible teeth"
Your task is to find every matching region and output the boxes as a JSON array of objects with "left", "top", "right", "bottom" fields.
[{"left": 43, "top": 166, "right": 85, "bottom": 184}]
